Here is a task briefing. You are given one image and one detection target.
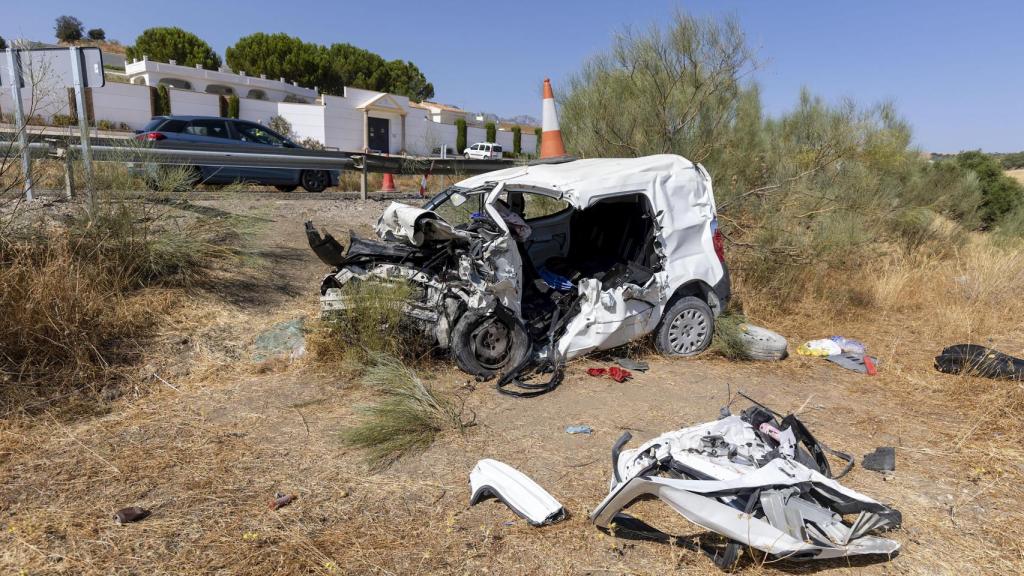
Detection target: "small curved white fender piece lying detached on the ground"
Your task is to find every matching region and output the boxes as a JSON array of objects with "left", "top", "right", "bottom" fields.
[{"left": 469, "top": 458, "right": 565, "bottom": 526}]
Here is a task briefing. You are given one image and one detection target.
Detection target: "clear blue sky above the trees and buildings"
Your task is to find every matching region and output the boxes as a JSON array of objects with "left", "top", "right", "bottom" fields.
[{"left": 0, "top": 0, "right": 1024, "bottom": 152}]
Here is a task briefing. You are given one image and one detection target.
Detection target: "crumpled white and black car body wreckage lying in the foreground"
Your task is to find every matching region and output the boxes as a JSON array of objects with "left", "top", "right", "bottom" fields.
[{"left": 590, "top": 397, "right": 901, "bottom": 569}]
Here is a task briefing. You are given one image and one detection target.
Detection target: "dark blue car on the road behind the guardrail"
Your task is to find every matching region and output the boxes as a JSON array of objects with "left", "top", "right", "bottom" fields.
[{"left": 135, "top": 116, "right": 339, "bottom": 192}]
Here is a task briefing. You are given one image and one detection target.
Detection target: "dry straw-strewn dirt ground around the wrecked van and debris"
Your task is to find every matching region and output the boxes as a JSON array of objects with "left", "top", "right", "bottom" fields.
[{"left": 0, "top": 190, "right": 1024, "bottom": 575}]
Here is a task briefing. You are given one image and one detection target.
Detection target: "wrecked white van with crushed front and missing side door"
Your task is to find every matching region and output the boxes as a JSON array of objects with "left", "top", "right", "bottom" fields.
[{"left": 307, "top": 155, "right": 729, "bottom": 396}]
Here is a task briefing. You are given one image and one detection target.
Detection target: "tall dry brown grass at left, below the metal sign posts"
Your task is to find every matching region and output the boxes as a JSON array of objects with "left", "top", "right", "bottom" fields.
[{"left": 0, "top": 179, "right": 247, "bottom": 413}]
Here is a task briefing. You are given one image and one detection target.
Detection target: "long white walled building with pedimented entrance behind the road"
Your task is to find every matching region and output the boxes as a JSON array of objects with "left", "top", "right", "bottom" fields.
[{"left": 0, "top": 54, "right": 537, "bottom": 156}]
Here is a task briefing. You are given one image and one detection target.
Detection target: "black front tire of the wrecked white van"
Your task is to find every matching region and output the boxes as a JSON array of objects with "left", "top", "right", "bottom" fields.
[{"left": 452, "top": 312, "right": 529, "bottom": 378}]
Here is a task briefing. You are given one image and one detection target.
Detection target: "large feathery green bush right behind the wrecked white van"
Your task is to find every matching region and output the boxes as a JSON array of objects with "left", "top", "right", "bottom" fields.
[{"left": 561, "top": 8, "right": 999, "bottom": 308}]
